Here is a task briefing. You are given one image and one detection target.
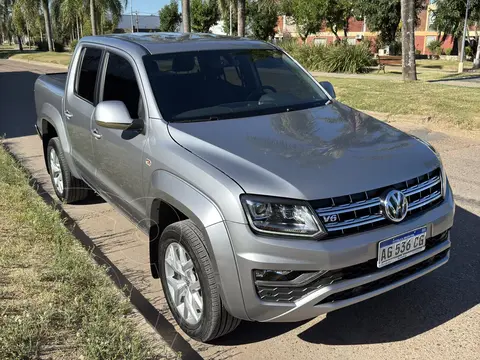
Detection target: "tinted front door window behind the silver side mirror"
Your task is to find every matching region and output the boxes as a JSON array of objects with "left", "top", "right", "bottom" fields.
[{"left": 102, "top": 54, "right": 142, "bottom": 119}]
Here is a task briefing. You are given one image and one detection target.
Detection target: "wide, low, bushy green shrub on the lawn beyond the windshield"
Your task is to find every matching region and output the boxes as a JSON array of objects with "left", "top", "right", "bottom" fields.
[{"left": 278, "top": 40, "right": 373, "bottom": 73}]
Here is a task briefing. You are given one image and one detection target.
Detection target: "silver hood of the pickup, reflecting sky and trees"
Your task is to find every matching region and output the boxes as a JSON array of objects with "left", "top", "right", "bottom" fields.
[{"left": 169, "top": 101, "right": 439, "bottom": 200}]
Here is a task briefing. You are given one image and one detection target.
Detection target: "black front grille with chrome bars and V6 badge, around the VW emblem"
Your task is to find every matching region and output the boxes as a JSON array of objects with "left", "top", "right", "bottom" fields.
[{"left": 312, "top": 169, "right": 442, "bottom": 237}]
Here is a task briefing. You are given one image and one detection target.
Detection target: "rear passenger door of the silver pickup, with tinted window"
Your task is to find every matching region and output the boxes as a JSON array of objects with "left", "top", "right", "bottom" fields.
[{"left": 64, "top": 45, "right": 103, "bottom": 187}]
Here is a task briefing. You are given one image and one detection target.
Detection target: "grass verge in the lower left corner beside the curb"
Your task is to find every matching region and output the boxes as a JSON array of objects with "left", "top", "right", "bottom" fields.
[{"left": 0, "top": 146, "right": 169, "bottom": 360}]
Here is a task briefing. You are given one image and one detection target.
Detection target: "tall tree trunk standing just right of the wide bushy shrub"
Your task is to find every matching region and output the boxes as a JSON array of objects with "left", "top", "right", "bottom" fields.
[{"left": 401, "top": 0, "right": 417, "bottom": 81}]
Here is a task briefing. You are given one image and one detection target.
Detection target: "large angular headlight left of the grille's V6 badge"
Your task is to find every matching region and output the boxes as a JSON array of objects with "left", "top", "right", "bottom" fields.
[{"left": 240, "top": 195, "right": 324, "bottom": 237}]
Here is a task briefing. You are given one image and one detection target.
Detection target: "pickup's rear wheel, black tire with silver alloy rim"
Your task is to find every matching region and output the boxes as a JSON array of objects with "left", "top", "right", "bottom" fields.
[{"left": 46, "top": 137, "right": 90, "bottom": 204}]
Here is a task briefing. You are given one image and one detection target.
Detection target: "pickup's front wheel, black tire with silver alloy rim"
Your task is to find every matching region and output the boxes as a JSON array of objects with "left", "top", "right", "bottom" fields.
[{"left": 158, "top": 220, "right": 240, "bottom": 342}]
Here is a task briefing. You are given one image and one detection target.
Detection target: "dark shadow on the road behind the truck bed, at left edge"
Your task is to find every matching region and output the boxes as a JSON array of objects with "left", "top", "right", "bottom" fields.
[{"left": 0, "top": 71, "right": 39, "bottom": 138}]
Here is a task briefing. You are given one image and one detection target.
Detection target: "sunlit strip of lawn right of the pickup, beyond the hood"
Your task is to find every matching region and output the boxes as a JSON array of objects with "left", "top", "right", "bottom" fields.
[{"left": 321, "top": 77, "right": 480, "bottom": 129}]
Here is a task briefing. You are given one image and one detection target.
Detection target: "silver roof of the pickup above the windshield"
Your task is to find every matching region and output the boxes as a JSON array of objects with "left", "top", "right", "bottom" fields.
[{"left": 82, "top": 32, "right": 274, "bottom": 54}]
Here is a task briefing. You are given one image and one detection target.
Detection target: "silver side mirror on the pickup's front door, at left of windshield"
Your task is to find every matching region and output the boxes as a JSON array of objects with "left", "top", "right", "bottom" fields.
[{"left": 93, "top": 100, "right": 136, "bottom": 130}]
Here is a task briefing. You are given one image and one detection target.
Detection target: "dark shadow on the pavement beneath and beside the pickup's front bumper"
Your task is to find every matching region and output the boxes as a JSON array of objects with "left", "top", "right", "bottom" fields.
[{"left": 215, "top": 206, "right": 480, "bottom": 345}]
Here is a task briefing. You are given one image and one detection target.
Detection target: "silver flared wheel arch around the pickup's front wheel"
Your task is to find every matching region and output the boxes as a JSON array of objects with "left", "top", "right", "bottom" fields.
[{"left": 147, "top": 170, "right": 248, "bottom": 319}]
